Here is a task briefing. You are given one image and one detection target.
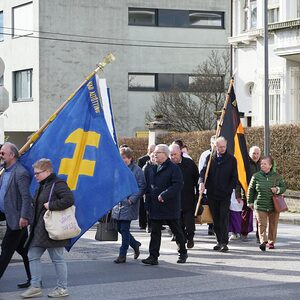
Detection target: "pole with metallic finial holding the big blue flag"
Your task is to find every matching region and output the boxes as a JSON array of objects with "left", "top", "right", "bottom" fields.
[{"left": 19, "top": 53, "right": 115, "bottom": 155}]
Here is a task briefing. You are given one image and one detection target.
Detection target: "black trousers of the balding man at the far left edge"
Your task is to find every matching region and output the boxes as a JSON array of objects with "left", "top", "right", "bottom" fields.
[{"left": 0, "top": 226, "right": 31, "bottom": 280}]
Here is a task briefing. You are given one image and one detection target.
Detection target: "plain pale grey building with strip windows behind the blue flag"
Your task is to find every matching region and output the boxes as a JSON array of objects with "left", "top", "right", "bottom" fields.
[{"left": 0, "top": 0, "right": 231, "bottom": 145}]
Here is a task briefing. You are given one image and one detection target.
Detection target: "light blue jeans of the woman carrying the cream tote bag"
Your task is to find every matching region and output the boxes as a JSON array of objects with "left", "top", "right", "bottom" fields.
[{"left": 28, "top": 247, "right": 68, "bottom": 289}]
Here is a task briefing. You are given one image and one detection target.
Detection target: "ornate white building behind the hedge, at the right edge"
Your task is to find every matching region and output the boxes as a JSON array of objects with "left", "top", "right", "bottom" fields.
[{"left": 229, "top": 0, "right": 300, "bottom": 126}]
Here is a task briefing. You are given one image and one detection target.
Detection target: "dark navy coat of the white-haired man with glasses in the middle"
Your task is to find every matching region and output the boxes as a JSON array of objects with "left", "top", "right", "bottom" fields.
[{"left": 145, "top": 159, "right": 183, "bottom": 220}]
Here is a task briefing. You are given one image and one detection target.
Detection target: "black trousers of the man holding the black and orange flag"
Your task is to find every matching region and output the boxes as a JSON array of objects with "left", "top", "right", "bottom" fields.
[{"left": 208, "top": 196, "right": 230, "bottom": 245}]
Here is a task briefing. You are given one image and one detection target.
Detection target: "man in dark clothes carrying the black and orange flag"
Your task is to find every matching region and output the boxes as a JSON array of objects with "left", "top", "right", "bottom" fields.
[{"left": 199, "top": 137, "right": 237, "bottom": 252}]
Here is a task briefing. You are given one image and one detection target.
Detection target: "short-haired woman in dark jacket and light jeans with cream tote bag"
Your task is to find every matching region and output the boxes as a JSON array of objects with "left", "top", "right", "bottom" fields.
[{"left": 21, "top": 158, "right": 74, "bottom": 298}]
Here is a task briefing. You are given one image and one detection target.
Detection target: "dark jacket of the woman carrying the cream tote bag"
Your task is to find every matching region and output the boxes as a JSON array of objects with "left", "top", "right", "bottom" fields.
[{"left": 28, "top": 174, "right": 74, "bottom": 248}]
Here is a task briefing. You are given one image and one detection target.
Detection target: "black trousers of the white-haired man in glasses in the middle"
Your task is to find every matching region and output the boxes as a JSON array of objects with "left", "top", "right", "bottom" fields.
[{"left": 149, "top": 219, "right": 187, "bottom": 259}]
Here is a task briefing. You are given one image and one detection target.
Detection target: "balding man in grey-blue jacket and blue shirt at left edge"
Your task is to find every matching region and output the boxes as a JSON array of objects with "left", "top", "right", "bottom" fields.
[{"left": 0, "top": 143, "right": 32, "bottom": 288}]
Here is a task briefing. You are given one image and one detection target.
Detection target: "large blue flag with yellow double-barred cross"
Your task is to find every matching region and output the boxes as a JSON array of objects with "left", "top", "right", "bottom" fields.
[{"left": 20, "top": 76, "right": 138, "bottom": 250}]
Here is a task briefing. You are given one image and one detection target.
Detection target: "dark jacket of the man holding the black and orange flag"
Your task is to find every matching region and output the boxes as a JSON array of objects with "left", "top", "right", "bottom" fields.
[{"left": 200, "top": 151, "right": 238, "bottom": 200}]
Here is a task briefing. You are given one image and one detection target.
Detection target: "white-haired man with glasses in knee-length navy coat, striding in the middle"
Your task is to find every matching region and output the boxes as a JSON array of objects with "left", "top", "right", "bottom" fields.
[{"left": 142, "top": 144, "right": 187, "bottom": 265}]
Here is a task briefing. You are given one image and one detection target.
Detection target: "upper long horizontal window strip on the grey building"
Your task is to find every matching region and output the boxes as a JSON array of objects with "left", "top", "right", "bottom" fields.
[{"left": 128, "top": 7, "right": 224, "bottom": 29}]
